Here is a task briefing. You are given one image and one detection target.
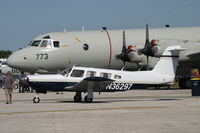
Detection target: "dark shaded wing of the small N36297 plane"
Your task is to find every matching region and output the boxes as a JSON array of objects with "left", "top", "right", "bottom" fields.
[{"left": 65, "top": 77, "right": 114, "bottom": 92}]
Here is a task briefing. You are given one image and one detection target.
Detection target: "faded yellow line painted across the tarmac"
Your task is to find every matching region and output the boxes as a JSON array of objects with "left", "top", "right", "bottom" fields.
[{"left": 0, "top": 106, "right": 169, "bottom": 115}]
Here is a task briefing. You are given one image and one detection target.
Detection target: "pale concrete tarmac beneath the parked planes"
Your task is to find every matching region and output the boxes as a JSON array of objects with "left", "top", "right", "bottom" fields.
[{"left": 0, "top": 89, "right": 200, "bottom": 133}]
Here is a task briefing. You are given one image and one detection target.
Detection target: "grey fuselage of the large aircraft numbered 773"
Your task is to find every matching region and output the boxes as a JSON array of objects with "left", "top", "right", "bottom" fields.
[{"left": 8, "top": 27, "right": 200, "bottom": 73}]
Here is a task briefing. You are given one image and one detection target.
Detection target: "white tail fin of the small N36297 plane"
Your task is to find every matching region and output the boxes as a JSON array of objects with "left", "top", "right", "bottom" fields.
[{"left": 152, "top": 46, "right": 184, "bottom": 76}]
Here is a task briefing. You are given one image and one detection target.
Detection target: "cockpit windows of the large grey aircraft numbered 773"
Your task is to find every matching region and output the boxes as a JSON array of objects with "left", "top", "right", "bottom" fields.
[{"left": 29, "top": 39, "right": 60, "bottom": 48}]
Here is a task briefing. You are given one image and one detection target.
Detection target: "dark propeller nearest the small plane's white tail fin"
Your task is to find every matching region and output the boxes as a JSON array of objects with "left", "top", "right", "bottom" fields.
[{"left": 139, "top": 24, "right": 157, "bottom": 70}]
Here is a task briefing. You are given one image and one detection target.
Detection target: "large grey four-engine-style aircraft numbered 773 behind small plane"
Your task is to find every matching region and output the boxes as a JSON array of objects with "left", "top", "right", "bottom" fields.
[{"left": 8, "top": 26, "right": 200, "bottom": 88}]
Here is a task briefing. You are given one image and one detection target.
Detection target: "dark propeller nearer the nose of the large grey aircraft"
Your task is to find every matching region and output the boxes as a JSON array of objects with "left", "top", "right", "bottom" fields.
[{"left": 116, "top": 30, "right": 130, "bottom": 66}]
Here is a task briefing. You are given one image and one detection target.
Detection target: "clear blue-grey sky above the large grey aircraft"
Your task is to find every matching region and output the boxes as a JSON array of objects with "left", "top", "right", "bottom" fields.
[{"left": 0, "top": 0, "right": 200, "bottom": 52}]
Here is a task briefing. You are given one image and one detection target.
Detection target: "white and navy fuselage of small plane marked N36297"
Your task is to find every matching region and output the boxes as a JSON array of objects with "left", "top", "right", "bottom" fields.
[{"left": 28, "top": 67, "right": 174, "bottom": 92}]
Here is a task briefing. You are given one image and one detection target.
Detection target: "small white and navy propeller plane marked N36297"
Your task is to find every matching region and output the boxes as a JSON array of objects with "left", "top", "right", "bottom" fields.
[{"left": 28, "top": 46, "right": 184, "bottom": 103}]
